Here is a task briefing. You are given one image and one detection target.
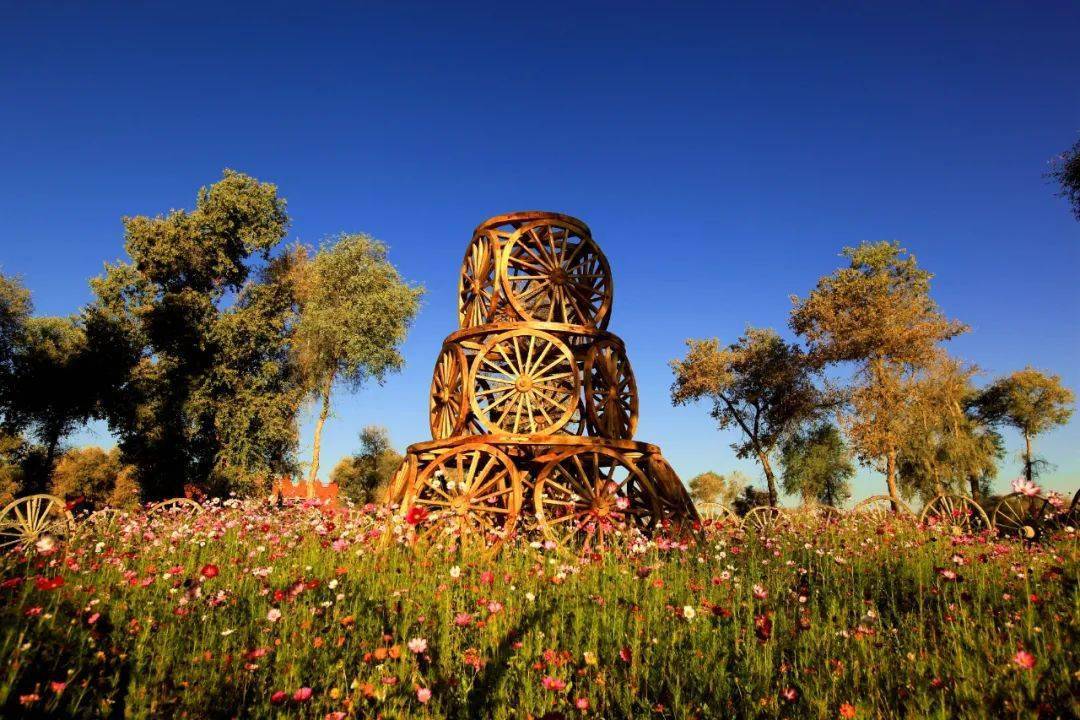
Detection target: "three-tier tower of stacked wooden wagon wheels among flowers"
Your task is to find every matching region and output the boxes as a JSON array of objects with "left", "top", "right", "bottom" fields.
[{"left": 386, "top": 212, "right": 698, "bottom": 549}]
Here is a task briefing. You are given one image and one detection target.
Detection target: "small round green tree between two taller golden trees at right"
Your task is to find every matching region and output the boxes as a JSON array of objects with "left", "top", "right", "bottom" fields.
[{"left": 780, "top": 422, "right": 855, "bottom": 507}]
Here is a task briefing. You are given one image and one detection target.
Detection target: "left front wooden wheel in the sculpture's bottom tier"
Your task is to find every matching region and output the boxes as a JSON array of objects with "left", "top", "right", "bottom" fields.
[{"left": 404, "top": 444, "right": 522, "bottom": 542}]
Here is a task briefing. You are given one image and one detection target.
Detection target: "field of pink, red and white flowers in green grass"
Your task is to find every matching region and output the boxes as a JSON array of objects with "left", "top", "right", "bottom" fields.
[{"left": 0, "top": 502, "right": 1080, "bottom": 718}]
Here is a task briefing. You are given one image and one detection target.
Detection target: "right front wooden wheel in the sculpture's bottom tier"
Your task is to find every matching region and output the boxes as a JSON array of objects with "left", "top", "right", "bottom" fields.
[{"left": 532, "top": 447, "right": 661, "bottom": 547}]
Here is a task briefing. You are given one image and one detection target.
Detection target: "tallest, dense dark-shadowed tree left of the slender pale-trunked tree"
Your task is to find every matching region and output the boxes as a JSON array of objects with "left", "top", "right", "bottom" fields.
[{"left": 83, "top": 171, "right": 298, "bottom": 499}]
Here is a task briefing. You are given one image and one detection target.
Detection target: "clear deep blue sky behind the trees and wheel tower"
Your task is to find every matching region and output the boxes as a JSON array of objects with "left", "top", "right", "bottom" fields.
[{"left": 0, "top": 0, "right": 1080, "bottom": 505}]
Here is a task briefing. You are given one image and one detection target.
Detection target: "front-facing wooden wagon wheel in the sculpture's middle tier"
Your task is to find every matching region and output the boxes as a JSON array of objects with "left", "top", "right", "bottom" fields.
[{"left": 469, "top": 328, "right": 580, "bottom": 435}]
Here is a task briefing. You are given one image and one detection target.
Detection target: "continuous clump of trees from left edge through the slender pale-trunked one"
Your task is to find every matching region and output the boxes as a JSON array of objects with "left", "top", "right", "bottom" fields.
[{"left": 0, "top": 171, "right": 423, "bottom": 504}]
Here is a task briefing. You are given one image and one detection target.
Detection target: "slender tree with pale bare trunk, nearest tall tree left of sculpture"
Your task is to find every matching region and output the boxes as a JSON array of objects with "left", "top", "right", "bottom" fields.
[{"left": 293, "top": 234, "right": 423, "bottom": 497}]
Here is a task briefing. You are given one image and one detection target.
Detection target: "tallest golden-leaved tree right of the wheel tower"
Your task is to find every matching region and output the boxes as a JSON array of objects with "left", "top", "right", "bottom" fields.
[{"left": 792, "top": 242, "right": 967, "bottom": 500}]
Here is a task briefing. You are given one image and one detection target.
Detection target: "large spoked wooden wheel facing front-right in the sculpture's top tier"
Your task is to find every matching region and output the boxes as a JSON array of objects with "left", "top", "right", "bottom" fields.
[{"left": 499, "top": 220, "right": 612, "bottom": 328}]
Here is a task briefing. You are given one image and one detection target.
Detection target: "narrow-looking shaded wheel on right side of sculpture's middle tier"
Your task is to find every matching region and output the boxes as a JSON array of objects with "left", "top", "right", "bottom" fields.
[{"left": 583, "top": 338, "right": 637, "bottom": 440}]
